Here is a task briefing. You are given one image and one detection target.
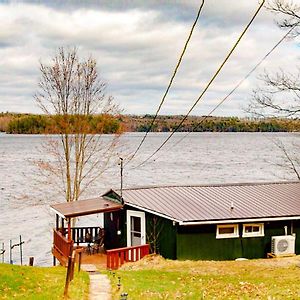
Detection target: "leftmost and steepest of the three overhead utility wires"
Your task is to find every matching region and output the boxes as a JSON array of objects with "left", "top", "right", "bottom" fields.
[{"left": 125, "top": 0, "right": 204, "bottom": 165}]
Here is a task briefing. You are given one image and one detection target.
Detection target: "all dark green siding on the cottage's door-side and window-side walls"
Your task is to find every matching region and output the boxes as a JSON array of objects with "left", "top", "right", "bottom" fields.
[{"left": 104, "top": 206, "right": 300, "bottom": 260}]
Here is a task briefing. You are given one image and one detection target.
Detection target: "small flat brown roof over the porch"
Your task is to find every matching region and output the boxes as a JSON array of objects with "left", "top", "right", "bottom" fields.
[{"left": 50, "top": 197, "right": 123, "bottom": 218}]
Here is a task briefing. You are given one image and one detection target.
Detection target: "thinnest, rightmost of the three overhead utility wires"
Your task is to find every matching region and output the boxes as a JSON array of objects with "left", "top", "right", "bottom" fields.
[{"left": 173, "top": 24, "right": 296, "bottom": 147}]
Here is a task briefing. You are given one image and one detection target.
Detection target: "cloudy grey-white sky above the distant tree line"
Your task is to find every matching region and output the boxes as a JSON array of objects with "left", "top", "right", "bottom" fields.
[{"left": 0, "top": 0, "right": 300, "bottom": 116}]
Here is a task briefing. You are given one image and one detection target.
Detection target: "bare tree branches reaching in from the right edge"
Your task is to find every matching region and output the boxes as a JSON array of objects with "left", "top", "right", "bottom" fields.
[{"left": 248, "top": 0, "right": 300, "bottom": 180}]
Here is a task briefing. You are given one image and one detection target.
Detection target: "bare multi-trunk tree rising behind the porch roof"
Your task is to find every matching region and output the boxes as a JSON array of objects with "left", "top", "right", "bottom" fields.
[{"left": 35, "top": 48, "right": 119, "bottom": 202}]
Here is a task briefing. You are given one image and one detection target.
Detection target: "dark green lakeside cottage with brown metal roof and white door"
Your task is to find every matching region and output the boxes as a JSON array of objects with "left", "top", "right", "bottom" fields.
[{"left": 53, "top": 182, "right": 300, "bottom": 260}]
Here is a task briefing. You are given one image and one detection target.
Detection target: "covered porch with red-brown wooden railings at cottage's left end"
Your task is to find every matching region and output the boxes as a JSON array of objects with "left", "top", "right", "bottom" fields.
[{"left": 51, "top": 197, "right": 149, "bottom": 269}]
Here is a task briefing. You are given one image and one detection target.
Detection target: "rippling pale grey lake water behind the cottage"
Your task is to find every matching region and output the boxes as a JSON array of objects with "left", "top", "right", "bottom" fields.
[{"left": 0, "top": 133, "right": 300, "bottom": 266}]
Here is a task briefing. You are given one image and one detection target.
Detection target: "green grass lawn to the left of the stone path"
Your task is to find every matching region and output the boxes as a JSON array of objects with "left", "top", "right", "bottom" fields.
[{"left": 0, "top": 264, "right": 89, "bottom": 299}]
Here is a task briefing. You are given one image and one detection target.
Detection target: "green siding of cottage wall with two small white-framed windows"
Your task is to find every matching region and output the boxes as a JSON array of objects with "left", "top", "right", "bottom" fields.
[{"left": 177, "top": 221, "right": 300, "bottom": 260}]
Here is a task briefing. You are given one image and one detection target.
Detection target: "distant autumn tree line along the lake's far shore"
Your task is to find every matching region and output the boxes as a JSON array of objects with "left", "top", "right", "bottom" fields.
[{"left": 0, "top": 113, "right": 300, "bottom": 134}]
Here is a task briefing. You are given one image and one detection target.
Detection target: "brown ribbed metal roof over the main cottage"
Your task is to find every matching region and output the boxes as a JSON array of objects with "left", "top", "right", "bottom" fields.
[{"left": 114, "top": 182, "right": 300, "bottom": 222}]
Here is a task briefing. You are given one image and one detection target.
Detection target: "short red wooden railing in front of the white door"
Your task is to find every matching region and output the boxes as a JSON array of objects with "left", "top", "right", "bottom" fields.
[{"left": 106, "top": 244, "right": 149, "bottom": 270}]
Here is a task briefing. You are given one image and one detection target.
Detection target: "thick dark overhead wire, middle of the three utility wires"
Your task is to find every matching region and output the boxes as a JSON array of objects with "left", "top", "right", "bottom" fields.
[{"left": 134, "top": 0, "right": 265, "bottom": 169}]
